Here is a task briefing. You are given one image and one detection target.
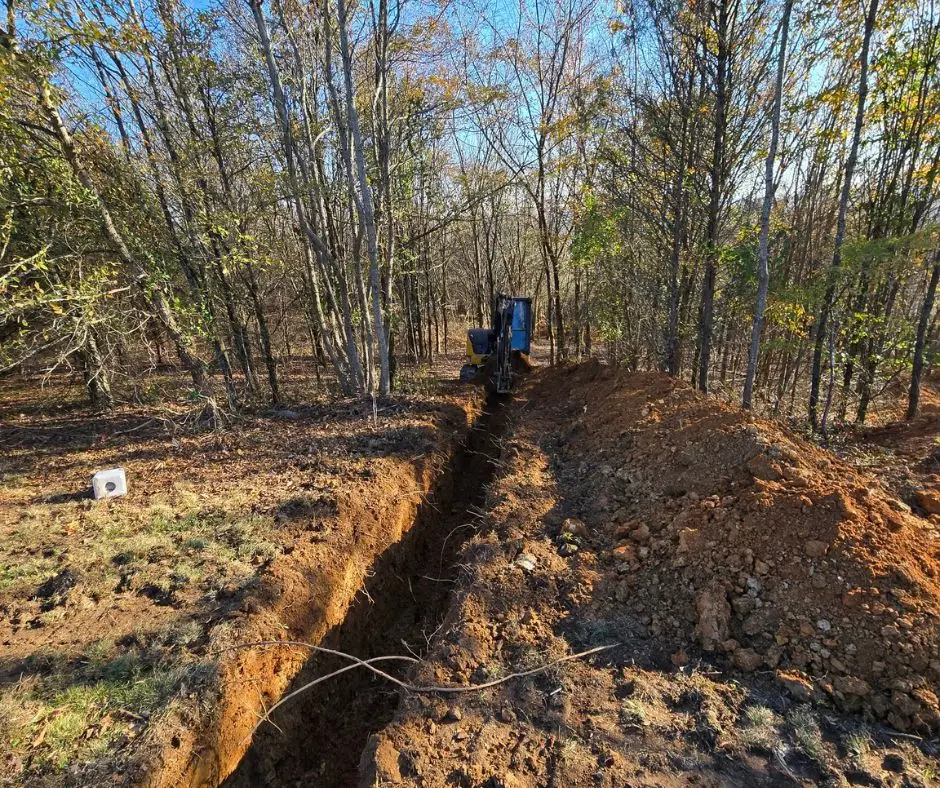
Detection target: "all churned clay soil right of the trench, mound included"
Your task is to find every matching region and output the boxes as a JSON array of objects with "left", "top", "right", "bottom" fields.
[{"left": 361, "top": 363, "right": 940, "bottom": 786}]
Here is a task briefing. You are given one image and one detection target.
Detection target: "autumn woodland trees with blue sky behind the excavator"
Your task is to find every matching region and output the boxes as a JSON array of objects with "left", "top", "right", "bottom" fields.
[{"left": 0, "top": 0, "right": 940, "bottom": 429}]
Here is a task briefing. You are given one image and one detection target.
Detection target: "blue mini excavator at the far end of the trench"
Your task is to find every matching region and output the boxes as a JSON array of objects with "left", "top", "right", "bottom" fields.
[{"left": 460, "top": 293, "right": 532, "bottom": 394}]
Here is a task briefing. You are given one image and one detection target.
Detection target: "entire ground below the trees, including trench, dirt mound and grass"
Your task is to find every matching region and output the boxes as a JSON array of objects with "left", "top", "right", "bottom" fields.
[{"left": 0, "top": 355, "right": 940, "bottom": 786}]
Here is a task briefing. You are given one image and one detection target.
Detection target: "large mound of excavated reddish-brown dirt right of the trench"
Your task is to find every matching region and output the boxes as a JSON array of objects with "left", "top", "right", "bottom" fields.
[{"left": 528, "top": 365, "right": 940, "bottom": 730}]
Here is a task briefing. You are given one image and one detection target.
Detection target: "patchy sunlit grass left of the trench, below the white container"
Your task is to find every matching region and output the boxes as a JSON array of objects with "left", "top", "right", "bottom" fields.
[{"left": 0, "top": 490, "right": 279, "bottom": 784}]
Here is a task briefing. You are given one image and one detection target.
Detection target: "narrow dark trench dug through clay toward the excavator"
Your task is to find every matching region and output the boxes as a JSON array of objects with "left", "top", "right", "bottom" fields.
[{"left": 223, "top": 395, "right": 505, "bottom": 788}]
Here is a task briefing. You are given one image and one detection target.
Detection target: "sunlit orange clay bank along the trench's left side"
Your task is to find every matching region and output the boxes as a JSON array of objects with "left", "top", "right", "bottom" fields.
[{"left": 132, "top": 390, "right": 482, "bottom": 787}]
